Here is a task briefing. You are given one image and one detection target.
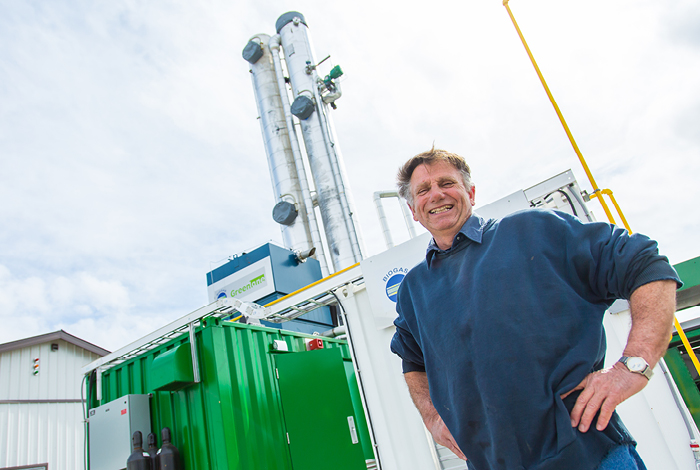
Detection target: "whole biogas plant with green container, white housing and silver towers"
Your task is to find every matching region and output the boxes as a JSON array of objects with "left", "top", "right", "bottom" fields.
[{"left": 83, "top": 12, "right": 697, "bottom": 470}]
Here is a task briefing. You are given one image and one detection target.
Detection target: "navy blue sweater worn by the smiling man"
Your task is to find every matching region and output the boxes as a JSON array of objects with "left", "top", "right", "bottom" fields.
[{"left": 391, "top": 210, "right": 679, "bottom": 470}]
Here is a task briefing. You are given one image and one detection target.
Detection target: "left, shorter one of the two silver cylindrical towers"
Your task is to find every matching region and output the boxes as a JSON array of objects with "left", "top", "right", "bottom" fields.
[{"left": 244, "top": 34, "right": 313, "bottom": 251}]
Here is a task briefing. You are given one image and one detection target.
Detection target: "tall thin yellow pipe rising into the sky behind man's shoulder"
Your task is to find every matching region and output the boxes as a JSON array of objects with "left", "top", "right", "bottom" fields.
[{"left": 503, "top": 0, "right": 700, "bottom": 374}]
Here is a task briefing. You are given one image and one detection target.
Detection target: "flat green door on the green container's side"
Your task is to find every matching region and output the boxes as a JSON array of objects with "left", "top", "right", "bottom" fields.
[{"left": 275, "top": 348, "right": 369, "bottom": 470}]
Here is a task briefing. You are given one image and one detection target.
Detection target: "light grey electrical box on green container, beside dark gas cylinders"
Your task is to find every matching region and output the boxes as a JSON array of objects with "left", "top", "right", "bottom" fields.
[{"left": 88, "top": 395, "right": 151, "bottom": 470}]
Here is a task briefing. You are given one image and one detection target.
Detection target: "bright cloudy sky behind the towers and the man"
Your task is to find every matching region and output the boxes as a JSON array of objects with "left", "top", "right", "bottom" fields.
[{"left": 0, "top": 0, "right": 700, "bottom": 350}]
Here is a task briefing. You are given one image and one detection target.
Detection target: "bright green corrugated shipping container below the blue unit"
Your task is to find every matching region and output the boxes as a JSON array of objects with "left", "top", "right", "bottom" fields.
[{"left": 88, "top": 317, "right": 375, "bottom": 470}]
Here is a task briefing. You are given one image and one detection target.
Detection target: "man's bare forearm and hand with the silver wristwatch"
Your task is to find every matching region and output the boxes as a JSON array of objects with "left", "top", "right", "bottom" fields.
[{"left": 563, "top": 280, "right": 677, "bottom": 432}]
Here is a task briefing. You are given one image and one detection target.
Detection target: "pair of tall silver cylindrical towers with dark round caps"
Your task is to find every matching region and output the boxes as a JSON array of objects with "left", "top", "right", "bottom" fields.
[{"left": 243, "top": 11, "right": 362, "bottom": 276}]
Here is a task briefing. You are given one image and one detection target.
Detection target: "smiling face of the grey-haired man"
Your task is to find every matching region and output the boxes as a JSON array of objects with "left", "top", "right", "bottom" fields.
[{"left": 409, "top": 162, "right": 475, "bottom": 250}]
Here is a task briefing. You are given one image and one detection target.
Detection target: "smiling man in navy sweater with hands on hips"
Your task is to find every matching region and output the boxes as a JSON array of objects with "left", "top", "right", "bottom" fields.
[{"left": 391, "top": 149, "right": 680, "bottom": 470}]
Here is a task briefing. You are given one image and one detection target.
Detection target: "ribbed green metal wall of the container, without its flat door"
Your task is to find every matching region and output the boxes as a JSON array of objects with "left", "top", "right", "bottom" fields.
[{"left": 90, "top": 318, "right": 349, "bottom": 470}]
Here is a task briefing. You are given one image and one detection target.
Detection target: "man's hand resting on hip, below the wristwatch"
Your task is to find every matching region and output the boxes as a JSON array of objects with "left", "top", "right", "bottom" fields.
[{"left": 561, "top": 362, "right": 649, "bottom": 432}]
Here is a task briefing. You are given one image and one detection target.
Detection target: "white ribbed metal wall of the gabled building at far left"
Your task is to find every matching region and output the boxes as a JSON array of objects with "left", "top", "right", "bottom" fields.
[{"left": 0, "top": 339, "right": 99, "bottom": 470}]
